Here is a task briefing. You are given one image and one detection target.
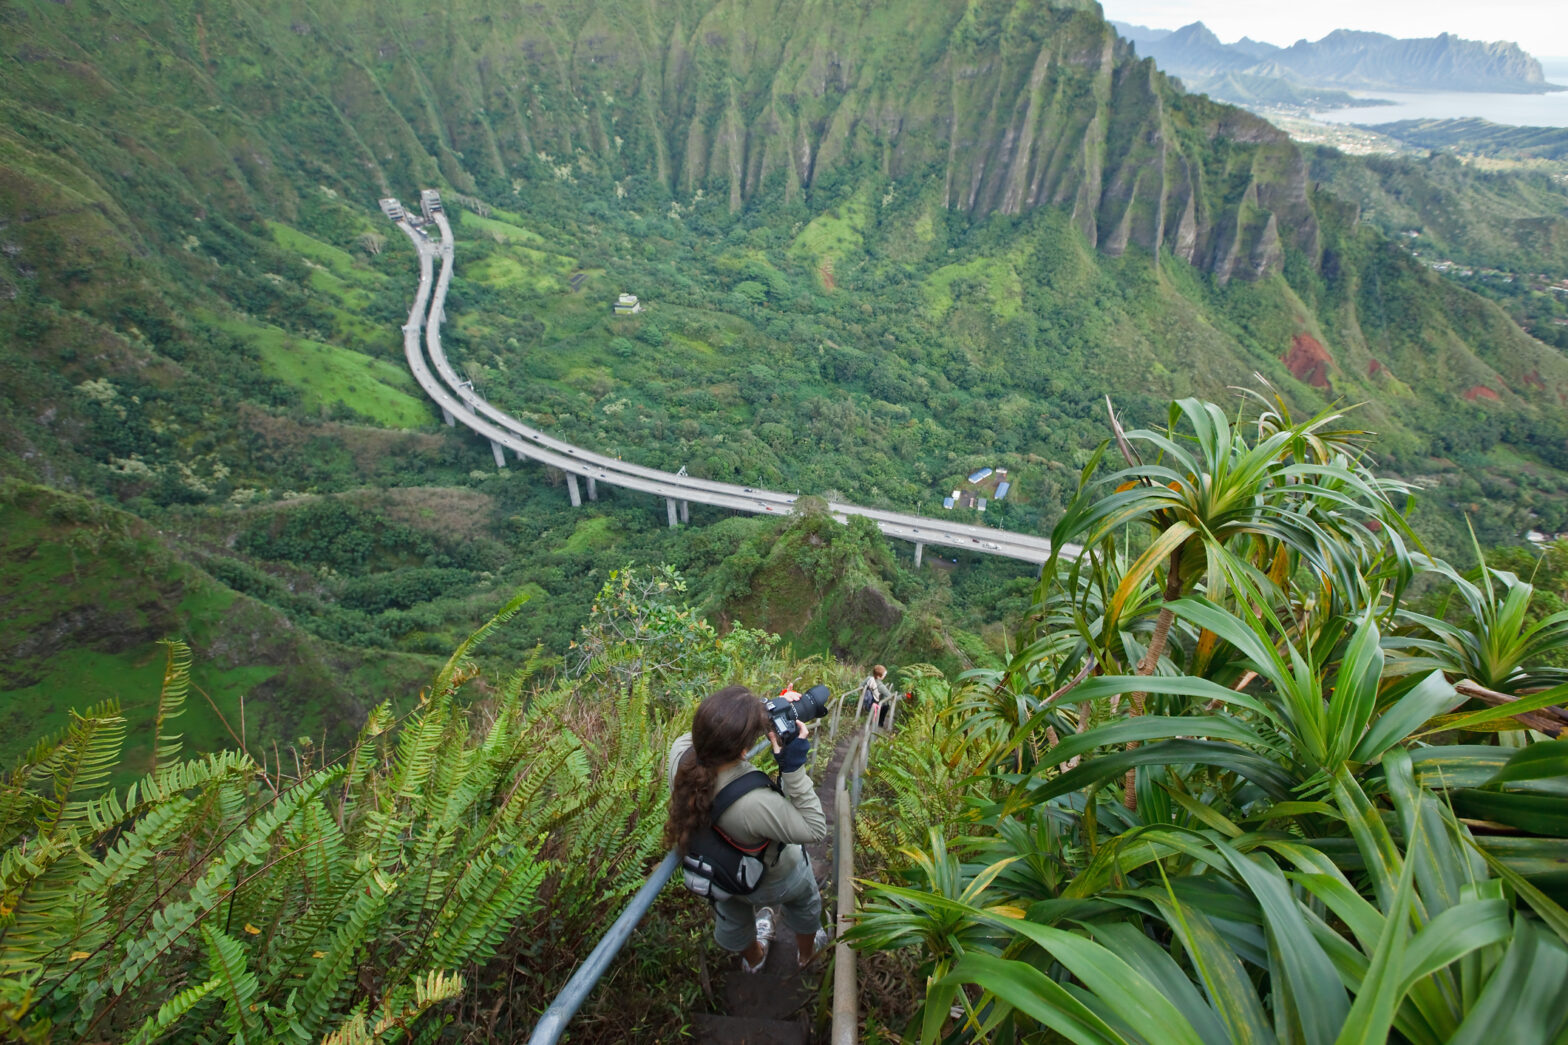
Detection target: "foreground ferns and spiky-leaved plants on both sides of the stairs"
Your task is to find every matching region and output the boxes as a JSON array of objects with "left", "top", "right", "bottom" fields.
[{"left": 9, "top": 395, "right": 1568, "bottom": 1045}]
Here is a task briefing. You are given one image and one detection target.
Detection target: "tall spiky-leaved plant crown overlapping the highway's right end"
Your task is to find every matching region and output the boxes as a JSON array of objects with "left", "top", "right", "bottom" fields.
[{"left": 1047, "top": 399, "right": 1408, "bottom": 807}]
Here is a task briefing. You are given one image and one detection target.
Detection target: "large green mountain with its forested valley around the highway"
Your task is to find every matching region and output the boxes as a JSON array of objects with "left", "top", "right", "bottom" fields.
[{"left": 0, "top": 0, "right": 1568, "bottom": 737}]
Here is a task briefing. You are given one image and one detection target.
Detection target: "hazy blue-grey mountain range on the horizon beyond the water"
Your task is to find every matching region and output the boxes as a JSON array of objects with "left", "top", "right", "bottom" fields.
[{"left": 1112, "top": 22, "right": 1563, "bottom": 108}]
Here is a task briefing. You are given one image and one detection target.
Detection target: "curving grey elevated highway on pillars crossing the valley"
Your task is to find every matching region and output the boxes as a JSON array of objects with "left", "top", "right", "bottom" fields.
[{"left": 385, "top": 196, "right": 1077, "bottom": 565}]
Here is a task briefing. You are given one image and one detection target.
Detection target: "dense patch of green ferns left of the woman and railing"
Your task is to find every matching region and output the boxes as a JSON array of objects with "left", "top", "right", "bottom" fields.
[{"left": 0, "top": 580, "right": 784, "bottom": 1043}]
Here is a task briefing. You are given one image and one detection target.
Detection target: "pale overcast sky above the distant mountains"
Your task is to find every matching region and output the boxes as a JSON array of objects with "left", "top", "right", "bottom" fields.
[{"left": 1101, "top": 0, "right": 1568, "bottom": 58}]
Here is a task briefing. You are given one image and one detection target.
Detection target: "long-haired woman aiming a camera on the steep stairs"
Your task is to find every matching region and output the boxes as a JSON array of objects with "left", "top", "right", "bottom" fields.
[{"left": 665, "top": 686, "right": 828, "bottom": 973}]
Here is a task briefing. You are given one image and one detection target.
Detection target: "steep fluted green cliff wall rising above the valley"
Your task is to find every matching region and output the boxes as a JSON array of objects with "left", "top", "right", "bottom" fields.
[{"left": 3, "top": 0, "right": 1319, "bottom": 279}]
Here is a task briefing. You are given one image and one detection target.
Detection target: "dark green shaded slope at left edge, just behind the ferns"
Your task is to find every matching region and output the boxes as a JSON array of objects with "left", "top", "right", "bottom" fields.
[{"left": 0, "top": 483, "right": 439, "bottom": 772}]
